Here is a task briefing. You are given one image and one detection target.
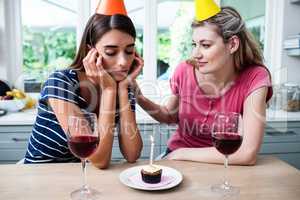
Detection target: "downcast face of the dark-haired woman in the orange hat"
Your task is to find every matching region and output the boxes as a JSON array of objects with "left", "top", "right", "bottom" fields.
[{"left": 95, "top": 29, "right": 135, "bottom": 81}]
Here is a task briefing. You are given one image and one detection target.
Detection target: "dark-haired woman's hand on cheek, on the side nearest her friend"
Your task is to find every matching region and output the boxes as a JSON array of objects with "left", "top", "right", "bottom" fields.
[{"left": 119, "top": 53, "right": 144, "bottom": 88}]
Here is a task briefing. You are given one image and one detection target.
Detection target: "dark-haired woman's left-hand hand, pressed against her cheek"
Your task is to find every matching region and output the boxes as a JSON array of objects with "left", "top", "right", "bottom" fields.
[{"left": 83, "top": 48, "right": 117, "bottom": 90}]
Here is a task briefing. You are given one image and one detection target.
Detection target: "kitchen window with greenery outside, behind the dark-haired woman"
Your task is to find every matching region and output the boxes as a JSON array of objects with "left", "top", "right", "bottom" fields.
[{"left": 21, "top": 0, "right": 144, "bottom": 92}]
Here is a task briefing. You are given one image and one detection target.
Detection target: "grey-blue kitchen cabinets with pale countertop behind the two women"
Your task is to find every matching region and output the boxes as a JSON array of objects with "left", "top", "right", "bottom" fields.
[{"left": 0, "top": 111, "right": 300, "bottom": 169}]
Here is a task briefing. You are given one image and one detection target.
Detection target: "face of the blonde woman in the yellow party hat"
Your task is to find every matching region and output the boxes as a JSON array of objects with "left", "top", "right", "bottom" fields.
[{"left": 192, "top": 24, "right": 233, "bottom": 74}]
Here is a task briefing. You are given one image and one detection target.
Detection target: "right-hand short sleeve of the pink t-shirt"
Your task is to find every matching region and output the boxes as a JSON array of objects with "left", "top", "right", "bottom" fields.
[{"left": 246, "top": 67, "right": 273, "bottom": 102}]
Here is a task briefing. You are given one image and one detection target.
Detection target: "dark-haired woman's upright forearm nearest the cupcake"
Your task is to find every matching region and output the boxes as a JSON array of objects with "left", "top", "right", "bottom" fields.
[{"left": 118, "top": 88, "right": 143, "bottom": 163}]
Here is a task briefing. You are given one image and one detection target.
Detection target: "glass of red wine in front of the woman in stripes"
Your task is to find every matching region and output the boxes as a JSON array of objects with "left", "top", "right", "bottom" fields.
[{"left": 67, "top": 113, "right": 100, "bottom": 200}]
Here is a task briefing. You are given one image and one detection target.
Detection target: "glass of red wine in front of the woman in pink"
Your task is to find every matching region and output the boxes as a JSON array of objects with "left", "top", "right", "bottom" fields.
[{"left": 211, "top": 112, "right": 243, "bottom": 195}]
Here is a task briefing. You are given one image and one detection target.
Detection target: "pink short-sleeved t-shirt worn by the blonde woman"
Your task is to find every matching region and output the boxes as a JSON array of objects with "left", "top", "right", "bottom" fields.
[{"left": 168, "top": 62, "right": 272, "bottom": 151}]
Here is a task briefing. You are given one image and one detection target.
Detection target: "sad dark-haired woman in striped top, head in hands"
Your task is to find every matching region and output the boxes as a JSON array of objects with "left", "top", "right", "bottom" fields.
[{"left": 24, "top": 4, "right": 143, "bottom": 168}]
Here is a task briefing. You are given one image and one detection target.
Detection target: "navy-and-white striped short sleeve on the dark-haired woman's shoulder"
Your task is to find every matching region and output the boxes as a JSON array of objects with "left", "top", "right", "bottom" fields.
[{"left": 41, "top": 71, "right": 78, "bottom": 104}]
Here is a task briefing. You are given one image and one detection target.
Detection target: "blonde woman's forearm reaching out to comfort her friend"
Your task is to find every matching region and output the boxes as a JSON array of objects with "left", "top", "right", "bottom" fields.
[{"left": 137, "top": 95, "right": 177, "bottom": 124}]
